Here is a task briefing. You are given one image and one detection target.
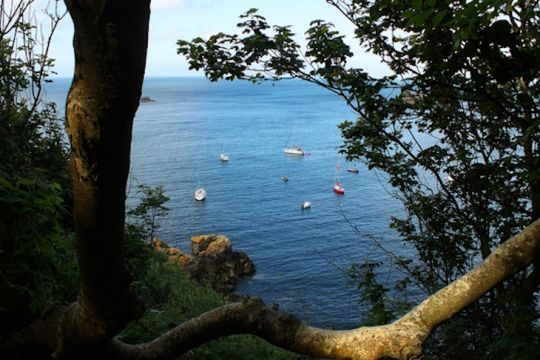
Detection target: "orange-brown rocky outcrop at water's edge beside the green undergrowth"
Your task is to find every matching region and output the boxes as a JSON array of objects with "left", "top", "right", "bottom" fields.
[{"left": 152, "top": 234, "right": 255, "bottom": 294}]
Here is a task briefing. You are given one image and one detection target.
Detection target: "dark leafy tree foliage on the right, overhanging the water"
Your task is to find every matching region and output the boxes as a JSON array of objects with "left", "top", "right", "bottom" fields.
[{"left": 178, "top": 0, "right": 540, "bottom": 358}]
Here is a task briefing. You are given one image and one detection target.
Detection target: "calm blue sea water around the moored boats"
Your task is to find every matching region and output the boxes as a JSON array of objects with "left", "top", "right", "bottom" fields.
[{"left": 48, "top": 78, "right": 418, "bottom": 328}]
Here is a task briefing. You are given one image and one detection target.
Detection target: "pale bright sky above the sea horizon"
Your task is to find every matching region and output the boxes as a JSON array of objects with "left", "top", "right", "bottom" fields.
[{"left": 35, "top": 0, "right": 386, "bottom": 77}]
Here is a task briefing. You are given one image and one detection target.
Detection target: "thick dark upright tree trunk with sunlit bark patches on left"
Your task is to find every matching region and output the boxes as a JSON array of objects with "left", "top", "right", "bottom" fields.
[{"left": 36, "top": 0, "right": 150, "bottom": 357}]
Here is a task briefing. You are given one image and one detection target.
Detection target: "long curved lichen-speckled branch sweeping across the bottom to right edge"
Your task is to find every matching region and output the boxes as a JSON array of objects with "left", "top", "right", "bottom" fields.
[{"left": 113, "top": 219, "right": 540, "bottom": 359}]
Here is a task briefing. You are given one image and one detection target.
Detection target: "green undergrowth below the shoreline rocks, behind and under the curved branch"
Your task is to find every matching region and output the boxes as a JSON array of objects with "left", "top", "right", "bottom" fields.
[{"left": 119, "top": 226, "right": 306, "bottom": 360}]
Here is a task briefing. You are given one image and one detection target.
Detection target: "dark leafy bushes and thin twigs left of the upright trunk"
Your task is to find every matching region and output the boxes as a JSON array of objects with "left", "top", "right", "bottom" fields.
[{"left": 0, "top": 1, "right": 73, "bottom": 342}]
